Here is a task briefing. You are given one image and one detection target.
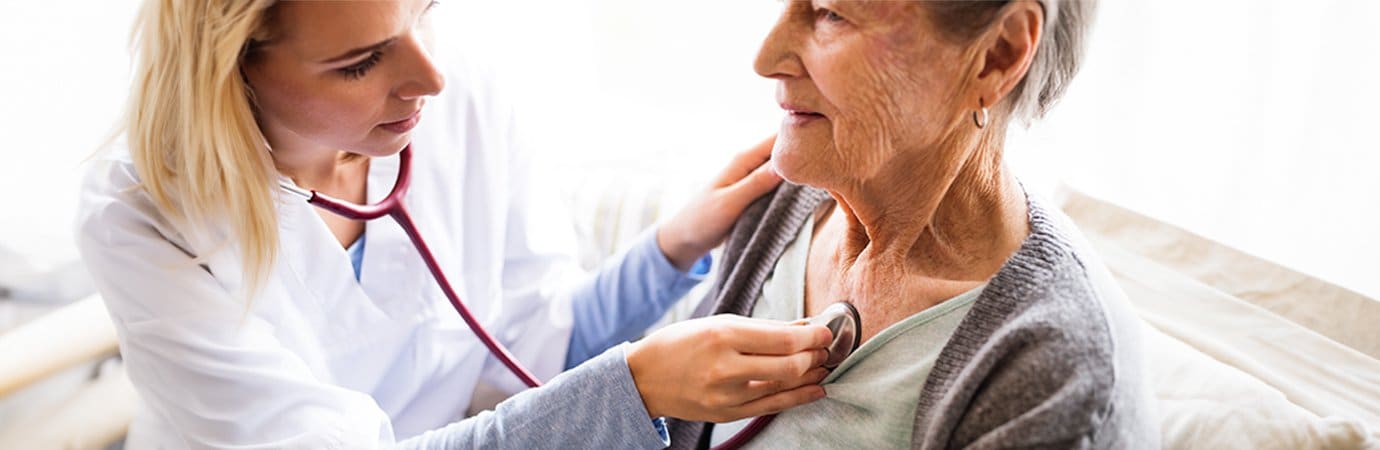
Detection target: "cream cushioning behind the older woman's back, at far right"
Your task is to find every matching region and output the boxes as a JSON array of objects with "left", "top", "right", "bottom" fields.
[{"left": 1063, "top": 188, "right": 1380, "bottom": 449}]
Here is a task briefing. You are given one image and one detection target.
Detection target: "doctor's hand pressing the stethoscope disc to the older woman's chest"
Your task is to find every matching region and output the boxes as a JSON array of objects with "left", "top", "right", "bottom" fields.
[{"left": 627, "top": 315, "right": 832, "bottom": 422}]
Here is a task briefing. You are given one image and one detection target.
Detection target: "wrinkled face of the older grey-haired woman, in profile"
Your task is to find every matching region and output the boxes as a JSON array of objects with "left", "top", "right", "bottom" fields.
[{"left": 756, "top": 0, "right": 972, "bottom": 188}]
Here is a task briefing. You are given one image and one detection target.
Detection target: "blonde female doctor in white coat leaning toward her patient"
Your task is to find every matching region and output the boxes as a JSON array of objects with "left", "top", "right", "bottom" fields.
[{"left": 77, "top": 0, "right": 829, "bottom": 449}]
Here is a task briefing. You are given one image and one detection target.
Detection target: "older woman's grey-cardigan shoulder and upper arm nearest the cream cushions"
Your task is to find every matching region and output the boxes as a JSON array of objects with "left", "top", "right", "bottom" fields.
[{"left": 922, "top": 199, "right": 1155, "bottom": 446}]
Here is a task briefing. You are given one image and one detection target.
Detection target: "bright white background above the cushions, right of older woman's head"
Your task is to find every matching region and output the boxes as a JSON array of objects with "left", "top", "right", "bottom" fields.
[{"left": 1017, "top": 0, "right": 1380, "bottom": 298}]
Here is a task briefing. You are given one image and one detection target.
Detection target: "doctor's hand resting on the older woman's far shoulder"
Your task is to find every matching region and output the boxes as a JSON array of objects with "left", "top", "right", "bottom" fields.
[{"left": 657, "top": 135, "right": 781, "bottom": 271}]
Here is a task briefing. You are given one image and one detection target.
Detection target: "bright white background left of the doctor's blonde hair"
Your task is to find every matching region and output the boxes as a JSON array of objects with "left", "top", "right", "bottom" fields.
[{"left": 0, "top": 0, "right": 137, "bottom": 268}]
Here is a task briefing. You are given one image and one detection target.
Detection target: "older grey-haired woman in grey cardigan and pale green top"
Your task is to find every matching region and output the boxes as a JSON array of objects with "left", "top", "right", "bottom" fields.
[{"left": 672, "top": 0, "right": 1158, "bottom": 449}]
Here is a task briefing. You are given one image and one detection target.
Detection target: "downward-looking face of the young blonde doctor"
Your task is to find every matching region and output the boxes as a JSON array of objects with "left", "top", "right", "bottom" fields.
[{"left": 242, "top": 0, "right": 444, "bottom": 156}]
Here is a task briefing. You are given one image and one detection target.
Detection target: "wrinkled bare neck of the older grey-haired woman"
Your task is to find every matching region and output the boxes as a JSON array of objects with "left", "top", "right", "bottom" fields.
[{"left": 816, "top": 127, "right": 1029, "bottom": 286}]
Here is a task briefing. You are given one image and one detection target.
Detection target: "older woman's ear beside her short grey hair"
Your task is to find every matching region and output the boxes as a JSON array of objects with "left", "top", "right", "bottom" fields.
[{"left": 973, "top": 1, "right": 1045, "bottom": 106}]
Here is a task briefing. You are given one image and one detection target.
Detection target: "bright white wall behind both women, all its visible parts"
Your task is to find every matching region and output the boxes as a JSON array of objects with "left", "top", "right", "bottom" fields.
[{"left": 0, "top": 0, "right": 1380, "bottom": 298}]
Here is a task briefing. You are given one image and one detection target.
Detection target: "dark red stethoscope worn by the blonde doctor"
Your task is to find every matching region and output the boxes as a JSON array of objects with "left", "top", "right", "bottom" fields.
[{"left": 279, "top": 144, "right": 863, "bottom": 450}]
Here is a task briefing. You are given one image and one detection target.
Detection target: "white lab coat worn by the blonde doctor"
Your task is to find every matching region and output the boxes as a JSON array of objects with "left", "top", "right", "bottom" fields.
[{"left": 77, "top": 61, "right": 580, "bottom": 449}]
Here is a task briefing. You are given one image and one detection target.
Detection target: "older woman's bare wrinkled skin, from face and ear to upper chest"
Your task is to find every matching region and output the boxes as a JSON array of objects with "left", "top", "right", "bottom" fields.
[{"left": 755, "top": 0, "right": 1043, "bottom": 340}]
